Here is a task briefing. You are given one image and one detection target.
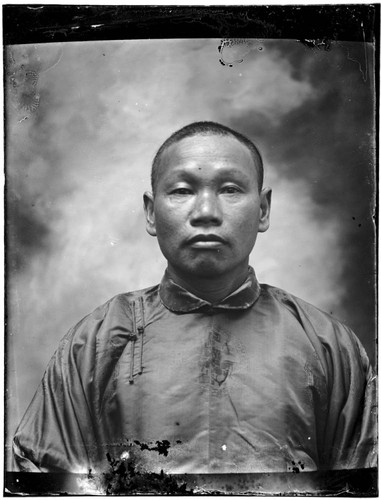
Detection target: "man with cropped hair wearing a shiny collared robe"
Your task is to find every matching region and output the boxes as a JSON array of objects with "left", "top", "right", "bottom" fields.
[{"left": 14, "top": 122, "right": 376, "bottom": 473}]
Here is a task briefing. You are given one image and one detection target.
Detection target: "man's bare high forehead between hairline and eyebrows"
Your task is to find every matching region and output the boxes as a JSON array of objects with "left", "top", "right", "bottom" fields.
[{"left": 160, "top": 134, "right": 257, "bottom": 177}]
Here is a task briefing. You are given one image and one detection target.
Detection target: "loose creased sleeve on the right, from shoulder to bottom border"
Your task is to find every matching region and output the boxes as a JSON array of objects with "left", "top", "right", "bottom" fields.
[{"left": 286, "top": 299, "right": 377, "bottom": 470}]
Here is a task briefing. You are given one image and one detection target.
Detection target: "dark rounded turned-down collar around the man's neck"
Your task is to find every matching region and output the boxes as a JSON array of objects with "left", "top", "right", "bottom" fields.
[{"left": 159, "top": 266, "right": 261, "bottom": 313}]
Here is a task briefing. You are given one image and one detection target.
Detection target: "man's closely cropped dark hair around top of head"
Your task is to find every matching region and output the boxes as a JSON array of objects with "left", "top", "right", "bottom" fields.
[{"left": 151, "top": 121, "right": 263, "bottom": 194}]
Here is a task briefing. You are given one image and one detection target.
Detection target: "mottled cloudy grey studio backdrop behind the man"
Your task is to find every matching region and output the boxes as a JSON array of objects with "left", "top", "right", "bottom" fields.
[{"left": 5, "top": 39, "right": 375, "bottom": 468}]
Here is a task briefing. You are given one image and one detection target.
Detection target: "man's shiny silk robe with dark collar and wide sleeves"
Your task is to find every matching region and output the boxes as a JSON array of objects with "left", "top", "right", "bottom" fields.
[{"left": 14, "top": 268, "right": 376, "bottom": 473}]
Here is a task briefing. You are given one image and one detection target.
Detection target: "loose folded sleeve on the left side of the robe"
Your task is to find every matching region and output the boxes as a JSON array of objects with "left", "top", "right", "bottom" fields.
[{"left": 13, "top": 319, "right": 102, "bottom": 472}]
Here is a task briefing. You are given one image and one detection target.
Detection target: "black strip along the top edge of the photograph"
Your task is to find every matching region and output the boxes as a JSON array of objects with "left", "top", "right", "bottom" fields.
[{"left": 3, "top": 4, "right": 380, "bottom": 45}]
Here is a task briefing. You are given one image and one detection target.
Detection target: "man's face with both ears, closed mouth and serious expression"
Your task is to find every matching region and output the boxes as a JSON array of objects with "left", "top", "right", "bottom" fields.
[{"left": 144, "top": 135, "right": 271, "bottom": 278}]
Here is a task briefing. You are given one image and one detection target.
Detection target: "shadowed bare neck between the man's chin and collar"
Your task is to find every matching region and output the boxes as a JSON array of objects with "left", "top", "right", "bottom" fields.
[{"left": 168, "top": 264, "right": 248, "bottom": 304}]
